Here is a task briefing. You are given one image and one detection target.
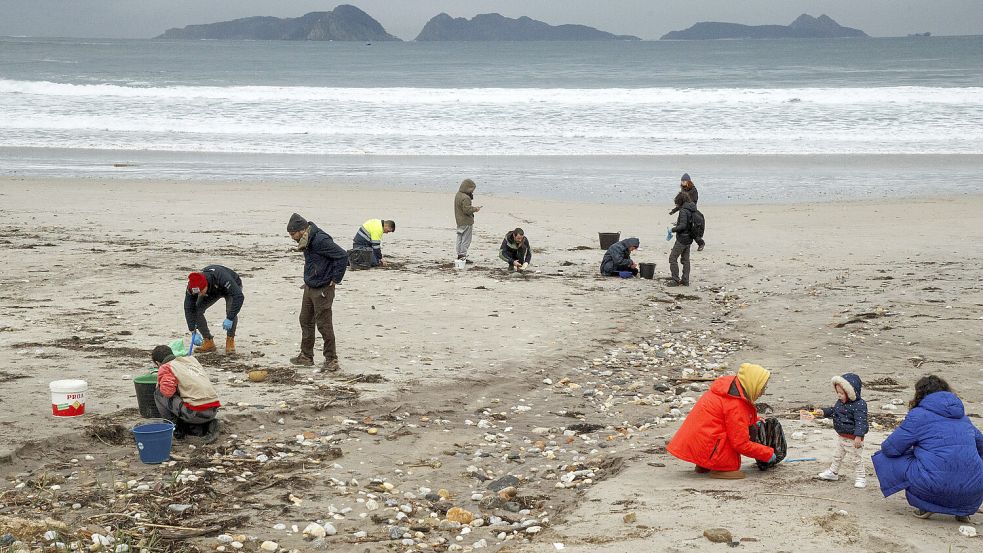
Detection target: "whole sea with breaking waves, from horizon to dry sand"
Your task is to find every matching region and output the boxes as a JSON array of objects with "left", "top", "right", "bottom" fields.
[{"left": 0, "top": 37, "right": 983, "bottom": 201}]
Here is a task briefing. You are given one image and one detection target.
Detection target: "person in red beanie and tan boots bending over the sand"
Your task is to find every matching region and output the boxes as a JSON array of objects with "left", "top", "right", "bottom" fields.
[{"left": 184, "top": 265, "right": 245, "bottom": 354}]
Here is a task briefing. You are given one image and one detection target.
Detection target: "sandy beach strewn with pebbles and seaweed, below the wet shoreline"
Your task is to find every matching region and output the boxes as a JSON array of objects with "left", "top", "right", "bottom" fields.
[{"left": 0, "top": 175, "right": 983, "bottom": 553}]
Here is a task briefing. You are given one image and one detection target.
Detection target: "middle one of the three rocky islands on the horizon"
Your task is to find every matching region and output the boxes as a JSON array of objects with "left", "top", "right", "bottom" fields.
[{"left": 416, "top": 13, "right": 641, "bottom": 42}]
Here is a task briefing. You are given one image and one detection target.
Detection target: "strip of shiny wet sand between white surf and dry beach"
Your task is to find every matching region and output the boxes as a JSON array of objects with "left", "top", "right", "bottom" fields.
[{"left": 0, "top": 148, "right": 983, "bottom": 205}]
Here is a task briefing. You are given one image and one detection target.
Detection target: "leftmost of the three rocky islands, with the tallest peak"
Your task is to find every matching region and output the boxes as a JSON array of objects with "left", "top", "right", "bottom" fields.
[{"left": 157, "top": 4, "right": 399, "bottom": 41}]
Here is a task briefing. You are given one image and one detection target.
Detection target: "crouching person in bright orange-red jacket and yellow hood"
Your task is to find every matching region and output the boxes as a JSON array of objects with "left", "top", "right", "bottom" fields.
[{"left": 666, "top": 363, "right": 775, "bottom": 479}]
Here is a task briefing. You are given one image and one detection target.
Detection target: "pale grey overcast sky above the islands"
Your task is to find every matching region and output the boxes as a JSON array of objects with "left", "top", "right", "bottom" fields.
[{"left": 0, "top": 0, "right": 983, "bottom": 40}]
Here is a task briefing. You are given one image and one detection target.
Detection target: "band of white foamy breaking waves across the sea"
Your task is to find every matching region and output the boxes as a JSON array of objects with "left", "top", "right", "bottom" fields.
[{"left": 0, "top": 79, "right": 983, "bottom": 155}]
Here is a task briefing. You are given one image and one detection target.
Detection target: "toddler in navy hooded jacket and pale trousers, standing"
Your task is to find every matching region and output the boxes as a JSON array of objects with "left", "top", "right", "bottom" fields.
[{"left": 813, "top": 373, "right": 870, "bottom": 488}]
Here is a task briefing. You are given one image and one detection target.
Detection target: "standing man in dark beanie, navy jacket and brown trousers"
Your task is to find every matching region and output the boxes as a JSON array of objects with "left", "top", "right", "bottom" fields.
[{"left": 287, "top": 213, "right": 348, "bottom": 371}]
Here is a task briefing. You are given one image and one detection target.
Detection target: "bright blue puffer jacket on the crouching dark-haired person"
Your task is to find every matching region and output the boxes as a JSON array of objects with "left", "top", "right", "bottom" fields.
[{"left": 873, "top": 392, "right": 983, "bottom": 516}]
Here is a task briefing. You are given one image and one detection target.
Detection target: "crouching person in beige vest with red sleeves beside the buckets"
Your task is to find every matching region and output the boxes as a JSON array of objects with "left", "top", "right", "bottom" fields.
[{"left": 151, "top": 346, "right": 222, "bottom": 443}]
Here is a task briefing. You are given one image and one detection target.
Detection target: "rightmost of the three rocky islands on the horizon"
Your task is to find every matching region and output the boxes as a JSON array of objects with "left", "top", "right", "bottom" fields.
[{"left": 661, "top": 14, "right": 867, "bottom": 40}]
